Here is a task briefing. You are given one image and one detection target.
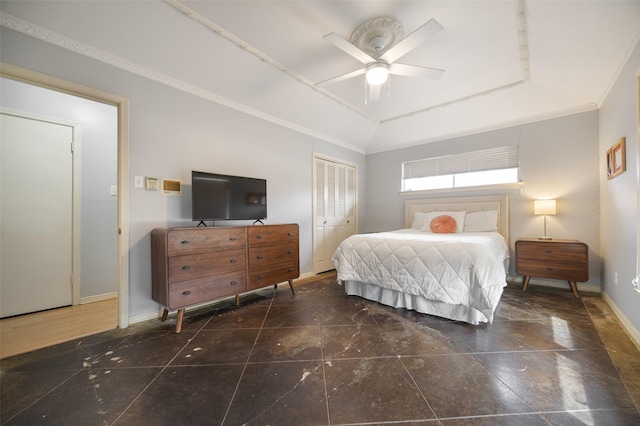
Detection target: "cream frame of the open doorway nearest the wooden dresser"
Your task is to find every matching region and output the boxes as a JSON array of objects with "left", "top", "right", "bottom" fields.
[{"left": 0, "top": 62, "right": 129, "bottom": 328}]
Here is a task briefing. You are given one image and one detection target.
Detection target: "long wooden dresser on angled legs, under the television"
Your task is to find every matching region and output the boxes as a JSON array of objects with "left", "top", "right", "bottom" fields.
[{"left": 151, "top": 224, "right": 300, "bottom": 333}]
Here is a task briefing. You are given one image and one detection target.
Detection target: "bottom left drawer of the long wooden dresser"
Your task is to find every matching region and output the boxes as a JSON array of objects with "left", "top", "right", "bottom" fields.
[{"left": 168, "top": 270, "right": 247, "bottom": 309}]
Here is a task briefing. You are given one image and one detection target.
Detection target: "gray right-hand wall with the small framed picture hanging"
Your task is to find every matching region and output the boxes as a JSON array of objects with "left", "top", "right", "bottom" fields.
[{"left": 598, "top": 44, "right": 640, "bottom": 341}]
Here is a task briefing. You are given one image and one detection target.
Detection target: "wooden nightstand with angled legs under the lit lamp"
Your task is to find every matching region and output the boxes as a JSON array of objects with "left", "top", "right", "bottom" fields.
[{"left": 516, "top": 238, "right": 589, "bottom": 298}]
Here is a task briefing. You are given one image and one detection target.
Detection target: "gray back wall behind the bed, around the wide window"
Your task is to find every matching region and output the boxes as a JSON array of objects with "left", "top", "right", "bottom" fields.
[{"left": 366, "top": 111, "right": 601, "bottom": 291}]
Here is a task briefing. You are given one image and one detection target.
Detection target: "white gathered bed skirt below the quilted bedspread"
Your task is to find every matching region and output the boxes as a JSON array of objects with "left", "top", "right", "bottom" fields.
[{"left": 342, "top": 281, "right": 491, "bottom": 325}]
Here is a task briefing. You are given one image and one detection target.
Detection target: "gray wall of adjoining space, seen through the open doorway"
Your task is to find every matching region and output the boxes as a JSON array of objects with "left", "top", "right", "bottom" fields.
[{"left": 0, "top": 79, "right": 118, "bottom": 298}]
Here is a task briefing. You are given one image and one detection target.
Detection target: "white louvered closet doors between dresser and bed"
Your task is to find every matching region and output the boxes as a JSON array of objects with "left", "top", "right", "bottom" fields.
[{"left": 313, "top": 157, "right": 356, "bottom": 273}]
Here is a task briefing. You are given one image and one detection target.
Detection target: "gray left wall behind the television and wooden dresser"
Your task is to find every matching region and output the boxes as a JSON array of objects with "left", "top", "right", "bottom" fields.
[{"left": 0, "top": 28, "right": 366, "bottom": 321}]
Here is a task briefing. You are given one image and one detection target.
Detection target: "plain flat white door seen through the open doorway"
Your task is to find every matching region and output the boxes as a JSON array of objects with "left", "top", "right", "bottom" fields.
[{"left": 0, "top": 113, "right": 73, "bottom": 318}]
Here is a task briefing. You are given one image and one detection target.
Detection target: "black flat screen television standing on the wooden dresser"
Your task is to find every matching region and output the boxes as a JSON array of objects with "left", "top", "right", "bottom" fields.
[{"left": 191, "top": 171, "right": 267, "bottom": 222}]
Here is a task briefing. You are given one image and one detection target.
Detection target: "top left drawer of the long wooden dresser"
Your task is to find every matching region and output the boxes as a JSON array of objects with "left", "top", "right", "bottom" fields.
[{"left": 167, "top": 228, "right": 246, "bottom": 256}]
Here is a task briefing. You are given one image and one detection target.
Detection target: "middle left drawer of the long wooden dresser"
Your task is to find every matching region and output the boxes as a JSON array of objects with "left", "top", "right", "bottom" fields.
[{"left": 169, "top": 249, "right": 246, "bottom": 283}]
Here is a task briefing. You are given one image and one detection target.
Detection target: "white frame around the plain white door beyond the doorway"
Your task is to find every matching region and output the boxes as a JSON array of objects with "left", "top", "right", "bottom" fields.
[{"left": 0, "top": 107, "right": 82, "bottom": 305}]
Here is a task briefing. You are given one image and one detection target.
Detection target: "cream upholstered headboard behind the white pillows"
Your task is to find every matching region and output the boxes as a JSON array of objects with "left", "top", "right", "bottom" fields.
[{"left": 404, "top": 195, "right": 509, "bottom": 243}]
